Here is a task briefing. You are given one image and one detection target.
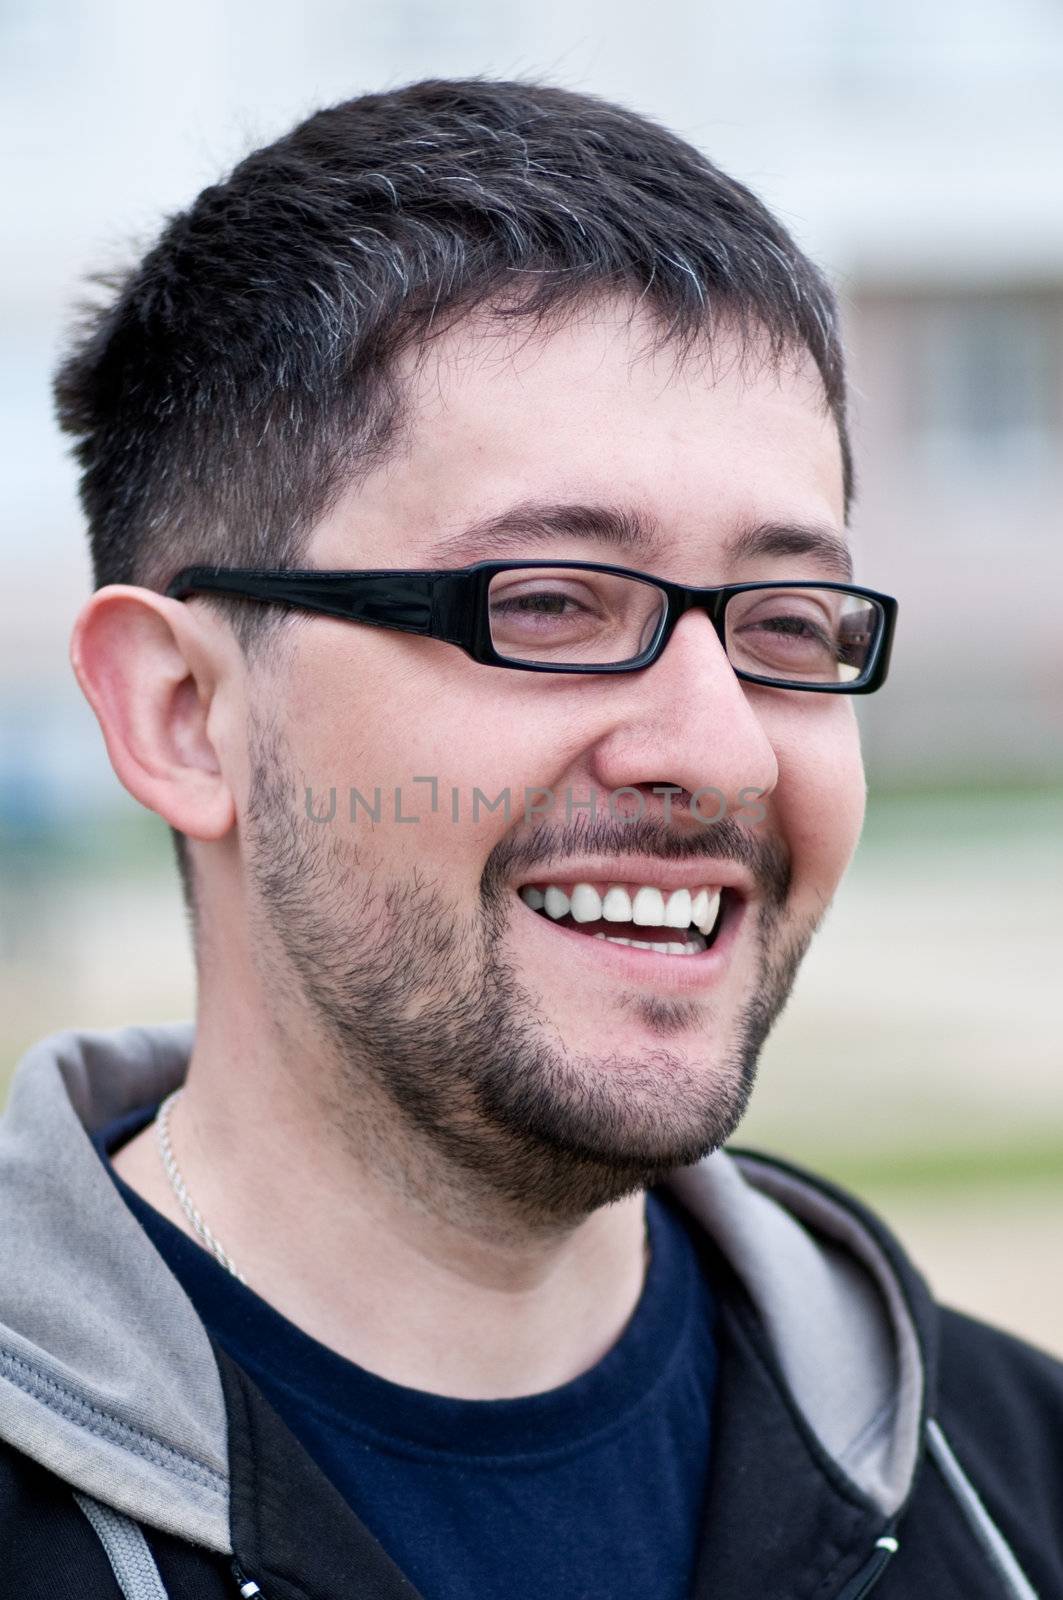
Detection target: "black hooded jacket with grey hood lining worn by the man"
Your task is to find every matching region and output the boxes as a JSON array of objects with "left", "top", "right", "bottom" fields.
[{"left": 0, "top": 1027, "right": 1063, "bottom": 1600}]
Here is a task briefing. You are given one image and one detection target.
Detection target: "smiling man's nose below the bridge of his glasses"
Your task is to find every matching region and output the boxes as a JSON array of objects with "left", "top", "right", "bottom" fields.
[{"left": 592, "top": 611, "right": 783, "bottom": 821}]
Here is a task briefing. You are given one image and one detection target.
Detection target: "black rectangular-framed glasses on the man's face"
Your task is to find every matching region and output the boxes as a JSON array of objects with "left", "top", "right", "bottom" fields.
[{"left": 165, "top": 562, "right": 897, "bottom": 694}]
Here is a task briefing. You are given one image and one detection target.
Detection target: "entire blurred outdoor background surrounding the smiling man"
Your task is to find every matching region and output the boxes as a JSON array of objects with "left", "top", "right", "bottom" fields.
[{"left": 0, "top": 0, "right": 1063, "bottom": 1355}]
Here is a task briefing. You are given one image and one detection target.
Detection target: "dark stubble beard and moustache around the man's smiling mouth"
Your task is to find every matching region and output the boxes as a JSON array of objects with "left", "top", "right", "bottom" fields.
[{"left": 247, "top": 725, "right": 816, "bottom": 1227}]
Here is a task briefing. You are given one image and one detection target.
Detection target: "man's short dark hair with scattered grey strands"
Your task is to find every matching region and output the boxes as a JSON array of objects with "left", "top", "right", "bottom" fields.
[{"left": 54, "top": 78, "right": 852, "bottom": 926}]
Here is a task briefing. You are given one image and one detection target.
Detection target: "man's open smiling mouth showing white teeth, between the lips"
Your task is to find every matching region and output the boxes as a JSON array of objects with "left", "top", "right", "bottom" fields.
[{"left": 519, "top": 883, "right": 736, "bottom": 955}]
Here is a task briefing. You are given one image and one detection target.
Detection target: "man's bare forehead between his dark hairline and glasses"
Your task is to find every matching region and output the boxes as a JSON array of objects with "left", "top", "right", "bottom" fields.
[{"left": 312, "top": 304, "right": 844, "bottom": 582}]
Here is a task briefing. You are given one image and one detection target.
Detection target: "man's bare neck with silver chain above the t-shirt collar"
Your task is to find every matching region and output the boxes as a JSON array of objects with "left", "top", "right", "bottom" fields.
[{"left": 114, "top": 1013, "right": 645, "bottom": 1398}]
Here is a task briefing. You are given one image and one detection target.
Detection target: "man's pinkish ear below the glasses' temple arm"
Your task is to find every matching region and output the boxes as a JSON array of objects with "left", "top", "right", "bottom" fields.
[{"left": 70, "top": 584, "right": 237, "bottom": 840}]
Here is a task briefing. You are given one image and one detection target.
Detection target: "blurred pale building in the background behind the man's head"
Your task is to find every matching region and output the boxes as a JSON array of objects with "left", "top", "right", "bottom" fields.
[{"left": 0, "top": 0, "right": 1063, "bottom": 851}]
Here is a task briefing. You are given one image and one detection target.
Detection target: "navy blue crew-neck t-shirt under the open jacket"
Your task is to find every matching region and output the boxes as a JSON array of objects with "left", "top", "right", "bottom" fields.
[{"left": 94, "top": 1107, "right": 716, "bottom": 1600}]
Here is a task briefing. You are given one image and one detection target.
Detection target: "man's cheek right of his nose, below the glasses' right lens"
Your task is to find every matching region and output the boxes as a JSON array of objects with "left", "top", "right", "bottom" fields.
[{"left": 773, "top": 696, "right": 866, "bottom": 906}]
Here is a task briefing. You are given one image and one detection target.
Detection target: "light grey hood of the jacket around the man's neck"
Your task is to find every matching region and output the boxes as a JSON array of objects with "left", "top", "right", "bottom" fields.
[{"left": 0, "top": 1022, "right": 925, "bottom": 1554}]
